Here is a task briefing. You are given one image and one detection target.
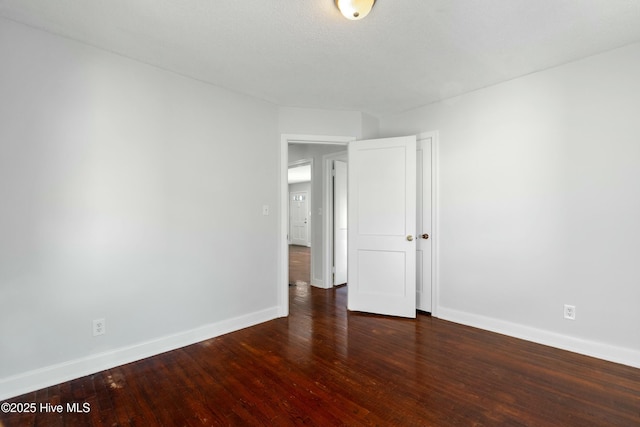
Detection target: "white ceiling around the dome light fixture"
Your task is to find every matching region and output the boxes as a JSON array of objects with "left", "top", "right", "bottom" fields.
[{"left": 0, "top": 0, "right": 640, "bottom": 116}]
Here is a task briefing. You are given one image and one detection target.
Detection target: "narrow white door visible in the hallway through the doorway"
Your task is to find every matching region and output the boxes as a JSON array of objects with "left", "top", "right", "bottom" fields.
[{"left": 333, "top": 160, "right": 348, "bottom": 286}]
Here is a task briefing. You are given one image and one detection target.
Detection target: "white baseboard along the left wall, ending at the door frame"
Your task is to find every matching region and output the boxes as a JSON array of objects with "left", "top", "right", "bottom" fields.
[{"left": 0, "top": 307, "right": 280, "bottom": 400}]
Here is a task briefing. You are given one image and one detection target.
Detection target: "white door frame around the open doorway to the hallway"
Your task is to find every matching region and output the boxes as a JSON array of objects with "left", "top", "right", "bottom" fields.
[{"left": 278, "top": 134, "right": 356, "bottom": 317}]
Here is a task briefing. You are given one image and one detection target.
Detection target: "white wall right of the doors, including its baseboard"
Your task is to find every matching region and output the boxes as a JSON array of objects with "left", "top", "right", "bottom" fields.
[{"left": 380, "top": 44, "right": 640, "bottom": 367}]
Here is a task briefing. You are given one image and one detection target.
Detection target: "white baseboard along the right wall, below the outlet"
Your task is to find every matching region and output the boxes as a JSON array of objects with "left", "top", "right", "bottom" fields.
[{"left": 437, "top": 307, "right": 640, "bottom": 368}]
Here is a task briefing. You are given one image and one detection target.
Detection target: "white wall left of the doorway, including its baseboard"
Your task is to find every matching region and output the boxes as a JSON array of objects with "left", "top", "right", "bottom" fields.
[{"left": 0, "top": 19, "right": 279, "bottom": 399}]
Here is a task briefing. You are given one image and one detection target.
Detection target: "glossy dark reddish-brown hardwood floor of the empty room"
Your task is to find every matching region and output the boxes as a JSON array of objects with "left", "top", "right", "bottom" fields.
[{"left": 0, "top": 285, "right": 640, "bottom": 427}]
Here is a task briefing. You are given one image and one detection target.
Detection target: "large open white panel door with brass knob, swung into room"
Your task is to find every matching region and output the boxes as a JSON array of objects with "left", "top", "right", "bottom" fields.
[{"left": 348, "top": 136, "right": 416, "bottom": 318}]
